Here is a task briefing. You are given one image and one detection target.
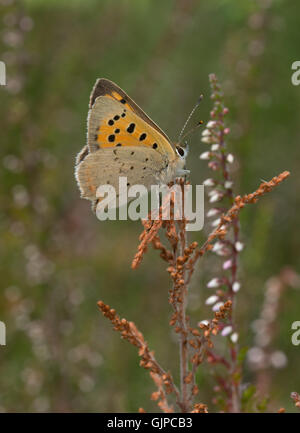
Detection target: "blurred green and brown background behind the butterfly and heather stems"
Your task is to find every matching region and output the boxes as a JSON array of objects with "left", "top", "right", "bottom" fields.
[{"left": 0, "top": 0, "right": 300, "bottom": 412}]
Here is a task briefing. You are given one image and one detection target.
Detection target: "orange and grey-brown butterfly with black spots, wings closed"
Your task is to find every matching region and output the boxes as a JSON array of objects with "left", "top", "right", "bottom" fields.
[{"left": 75, "top": 78, "right": 188, "bottom": 211}]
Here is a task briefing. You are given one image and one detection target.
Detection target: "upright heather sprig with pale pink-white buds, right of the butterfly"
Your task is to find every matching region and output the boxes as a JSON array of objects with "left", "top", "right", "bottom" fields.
[{"left": 200, "top": 74, "right": 244, "bottom": 412}]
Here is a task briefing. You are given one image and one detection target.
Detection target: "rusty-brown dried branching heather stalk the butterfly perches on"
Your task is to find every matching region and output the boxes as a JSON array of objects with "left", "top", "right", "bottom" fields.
[{"left": 98, "top": 168, "right": 289, "bottom": 412}]
